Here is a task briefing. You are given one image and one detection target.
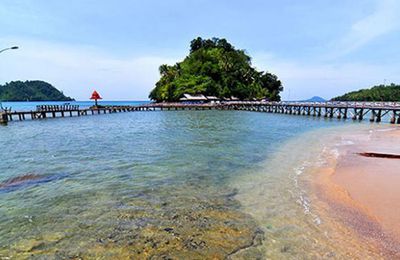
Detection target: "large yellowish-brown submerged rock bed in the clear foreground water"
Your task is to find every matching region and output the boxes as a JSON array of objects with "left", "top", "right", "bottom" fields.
[{"left": 6, "top": 187, "right": 264, "bottom": 259}]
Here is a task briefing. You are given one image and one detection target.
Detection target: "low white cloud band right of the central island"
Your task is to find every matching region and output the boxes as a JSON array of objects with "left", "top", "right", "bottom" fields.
[{"left": 254, "top": 53, "right": 400, "bottom": 100}]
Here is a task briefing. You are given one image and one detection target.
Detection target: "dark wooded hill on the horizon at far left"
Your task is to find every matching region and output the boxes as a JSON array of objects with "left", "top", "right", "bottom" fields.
[{"left": 0, "top": 80, "right": 73, "bottom": 101}]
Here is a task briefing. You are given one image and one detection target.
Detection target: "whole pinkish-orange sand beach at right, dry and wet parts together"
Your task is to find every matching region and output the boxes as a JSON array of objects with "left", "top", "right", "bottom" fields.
[{"left": 316, "top": 127, "right": 400, "bottom": 258}]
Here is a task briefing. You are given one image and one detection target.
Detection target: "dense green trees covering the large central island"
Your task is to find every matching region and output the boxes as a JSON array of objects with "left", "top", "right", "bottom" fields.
[{"left": 149, "top": 37, "right": 283, "bottom": 102}]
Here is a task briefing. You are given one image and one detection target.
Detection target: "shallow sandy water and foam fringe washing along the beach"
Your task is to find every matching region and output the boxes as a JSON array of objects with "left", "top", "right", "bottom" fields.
[{"left": 234, "top": 125, "right": 389, "bottom": 259}]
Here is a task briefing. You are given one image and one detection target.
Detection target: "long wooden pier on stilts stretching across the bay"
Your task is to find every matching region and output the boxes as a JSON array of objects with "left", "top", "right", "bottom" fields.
[{"left": 0, "top": 101, "right": 400, "bottom": 124}]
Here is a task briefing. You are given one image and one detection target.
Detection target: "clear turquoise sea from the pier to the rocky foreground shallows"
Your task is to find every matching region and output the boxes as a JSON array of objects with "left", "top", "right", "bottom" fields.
[{"left": 0, "top": 107, "right": 362, "bottom": 258}]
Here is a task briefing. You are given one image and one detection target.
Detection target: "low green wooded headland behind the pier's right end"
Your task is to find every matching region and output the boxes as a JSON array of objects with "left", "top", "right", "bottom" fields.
[{"left": 332, "top": 83, "right": 400, "bottom": 101}]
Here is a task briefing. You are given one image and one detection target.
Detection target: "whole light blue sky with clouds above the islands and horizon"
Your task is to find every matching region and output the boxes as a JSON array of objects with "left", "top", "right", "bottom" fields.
[{"left": 0, "top": 0, "right": 400, "bottom": 100}]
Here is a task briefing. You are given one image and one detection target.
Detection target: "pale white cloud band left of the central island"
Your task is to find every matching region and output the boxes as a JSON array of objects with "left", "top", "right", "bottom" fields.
[{"left": 0, "top": 39, "right": 178, "bottom": 100}]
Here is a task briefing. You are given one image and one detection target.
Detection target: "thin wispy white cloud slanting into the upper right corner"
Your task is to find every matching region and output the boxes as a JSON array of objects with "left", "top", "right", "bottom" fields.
[{"left": 333, "top": 0, "right": 400, "bottom": 56}]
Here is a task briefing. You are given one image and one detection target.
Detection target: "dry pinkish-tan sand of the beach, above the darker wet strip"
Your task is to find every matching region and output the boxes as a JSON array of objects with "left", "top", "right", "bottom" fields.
[{"left": 332, "top": 129, "right": 400, "bottom": 241}]
